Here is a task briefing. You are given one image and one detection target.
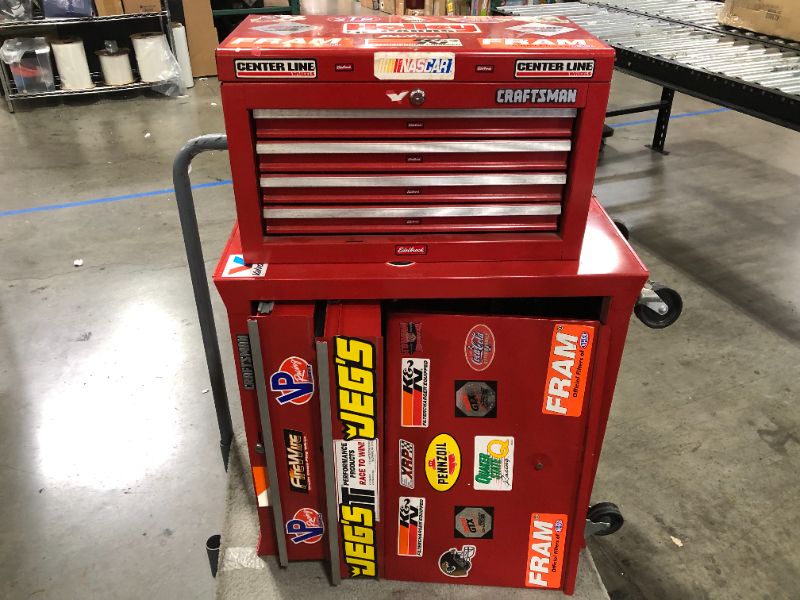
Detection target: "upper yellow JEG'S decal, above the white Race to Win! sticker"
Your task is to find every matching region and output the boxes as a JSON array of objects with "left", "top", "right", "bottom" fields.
[{"left": 333, "top": 336, "right": 377, "bottom": 440}]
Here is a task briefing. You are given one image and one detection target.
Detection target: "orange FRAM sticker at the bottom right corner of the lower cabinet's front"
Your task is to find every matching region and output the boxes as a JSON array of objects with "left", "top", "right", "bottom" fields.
[{"left": 525, "top": 513, "right": 567, "bottom": 588}]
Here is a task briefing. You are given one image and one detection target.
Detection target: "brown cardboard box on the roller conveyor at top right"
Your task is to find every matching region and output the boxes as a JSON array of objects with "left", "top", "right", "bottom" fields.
[{"left": 718, "top": 0, "right": 800, "bottom": 41}]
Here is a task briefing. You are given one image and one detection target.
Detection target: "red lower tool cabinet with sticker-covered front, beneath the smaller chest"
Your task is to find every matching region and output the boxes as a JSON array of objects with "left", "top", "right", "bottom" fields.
[{"left": 214, "top": 200, "right": 647, "bottom": 593}]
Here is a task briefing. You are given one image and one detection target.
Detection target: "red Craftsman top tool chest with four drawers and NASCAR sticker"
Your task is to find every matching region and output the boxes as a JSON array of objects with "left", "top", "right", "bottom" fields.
[{"left": 217, "top": 16, "right": 614, "bottom": 263}]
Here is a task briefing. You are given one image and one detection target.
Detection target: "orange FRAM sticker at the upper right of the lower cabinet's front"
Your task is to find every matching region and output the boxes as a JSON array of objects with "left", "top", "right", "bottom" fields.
[{"left": 542, "top": 323, "right": 595, "bottom": 417}]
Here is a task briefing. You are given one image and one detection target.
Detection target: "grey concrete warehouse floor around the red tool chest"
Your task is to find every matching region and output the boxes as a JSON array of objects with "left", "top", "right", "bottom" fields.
[{"left": 0, "top": 18, "right": 800, "bottom": 600}]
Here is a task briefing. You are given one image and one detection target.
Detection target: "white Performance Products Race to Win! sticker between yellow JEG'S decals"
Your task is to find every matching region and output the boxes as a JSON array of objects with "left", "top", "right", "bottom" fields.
[{"left": 333, "top": 439, "right": 380, "bottom": 521}]
